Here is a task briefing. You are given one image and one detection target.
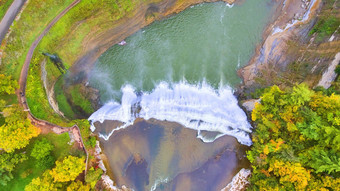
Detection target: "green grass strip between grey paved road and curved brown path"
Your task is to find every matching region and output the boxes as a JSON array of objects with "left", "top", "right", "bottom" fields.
[{"left": 0, "top": 0, "right": 72, "bottom": 79}]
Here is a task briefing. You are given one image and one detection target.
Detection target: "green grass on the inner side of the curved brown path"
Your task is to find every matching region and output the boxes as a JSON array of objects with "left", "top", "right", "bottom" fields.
[{"left": 27, "top": 0, "right": 149, "bottom": 124}]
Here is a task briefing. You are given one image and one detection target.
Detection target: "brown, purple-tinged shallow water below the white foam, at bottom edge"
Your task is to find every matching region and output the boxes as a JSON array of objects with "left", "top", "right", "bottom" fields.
[{"left": 95, "top": 119, "right": 249, "bottom": 191}]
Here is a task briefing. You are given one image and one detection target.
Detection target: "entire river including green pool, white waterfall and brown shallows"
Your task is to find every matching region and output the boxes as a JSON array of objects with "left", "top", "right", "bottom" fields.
[{"left": 89, "top": 0, "right": 275, "bottom": 190}]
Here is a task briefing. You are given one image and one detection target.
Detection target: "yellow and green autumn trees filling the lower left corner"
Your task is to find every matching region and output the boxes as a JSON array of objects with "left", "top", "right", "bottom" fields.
[{"left": 0, "top": 74, "right": 103, "bottom": 191}]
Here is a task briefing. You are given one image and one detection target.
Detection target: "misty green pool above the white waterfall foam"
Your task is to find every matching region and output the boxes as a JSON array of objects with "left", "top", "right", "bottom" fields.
[{"left": 90, "top": 0, "right": 272, "bottom": 102}]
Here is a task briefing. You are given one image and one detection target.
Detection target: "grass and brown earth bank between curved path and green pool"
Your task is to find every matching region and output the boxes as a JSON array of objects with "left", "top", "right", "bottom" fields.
[{"left": 21, "top": 0, "right": 242, "bottom": 121}]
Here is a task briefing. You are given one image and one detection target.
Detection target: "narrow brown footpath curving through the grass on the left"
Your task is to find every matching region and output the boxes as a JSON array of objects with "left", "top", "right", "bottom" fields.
[{"left": 16, "top": 0, "right": 87, "bottom": 149}]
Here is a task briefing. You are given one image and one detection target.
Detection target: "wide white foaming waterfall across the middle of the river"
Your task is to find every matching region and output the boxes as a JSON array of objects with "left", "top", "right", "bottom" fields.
[{"left": 89, "top": 82, "right": 252, "bottom": 145}]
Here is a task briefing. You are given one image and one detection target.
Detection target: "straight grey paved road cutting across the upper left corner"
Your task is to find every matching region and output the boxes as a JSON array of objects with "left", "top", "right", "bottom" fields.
[{"left": 0, "top": 0, "right": 26, "bottom": 44}]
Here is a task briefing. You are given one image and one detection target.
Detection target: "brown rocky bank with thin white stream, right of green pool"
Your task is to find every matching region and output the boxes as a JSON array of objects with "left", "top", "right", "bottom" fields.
[{"left": 239, "top": 0, "right": 322, "bottom": 87}]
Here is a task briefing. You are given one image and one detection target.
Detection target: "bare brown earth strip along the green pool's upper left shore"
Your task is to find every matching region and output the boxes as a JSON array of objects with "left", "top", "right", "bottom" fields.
[{"left": 70, "top": 0, "right": 235, "bottom": 80}]
